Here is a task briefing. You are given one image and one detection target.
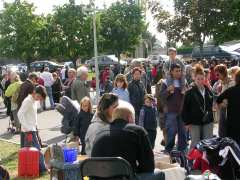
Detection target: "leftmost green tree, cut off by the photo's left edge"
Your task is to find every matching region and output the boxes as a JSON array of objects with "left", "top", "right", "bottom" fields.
[{"left": 0, "top": 0, "right": 44, "bottom": 64}]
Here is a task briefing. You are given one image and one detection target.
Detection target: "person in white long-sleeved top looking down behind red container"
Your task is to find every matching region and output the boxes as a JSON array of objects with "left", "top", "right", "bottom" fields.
[{"left": 17, "top": 85, "right": 46, "bottom": 172}]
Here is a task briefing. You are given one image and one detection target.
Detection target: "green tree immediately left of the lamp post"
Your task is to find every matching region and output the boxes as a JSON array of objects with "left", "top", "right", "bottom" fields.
[{"left": 50, "top": 0, "right": 93, "bottom": 62}]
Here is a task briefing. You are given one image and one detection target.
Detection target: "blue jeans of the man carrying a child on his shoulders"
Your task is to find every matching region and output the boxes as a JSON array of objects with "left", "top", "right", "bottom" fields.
[{"left": 165, "top": 113, "right": 187, "bottom": 152}]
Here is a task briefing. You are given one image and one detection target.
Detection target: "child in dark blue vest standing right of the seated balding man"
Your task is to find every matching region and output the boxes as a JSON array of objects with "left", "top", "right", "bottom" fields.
[{"left": 139, "top": 94, "right": 157, "bottom": 149}]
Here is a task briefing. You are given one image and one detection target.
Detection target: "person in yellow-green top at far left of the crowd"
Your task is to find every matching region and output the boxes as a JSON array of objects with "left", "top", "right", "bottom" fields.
[{"left": 5, "top": 72, "right": 22, "bottom": 133}]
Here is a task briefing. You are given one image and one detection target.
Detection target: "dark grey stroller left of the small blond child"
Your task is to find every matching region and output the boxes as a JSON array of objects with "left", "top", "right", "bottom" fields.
[{"left": 56, "top": 96, "right": 80, "bottom": 142}]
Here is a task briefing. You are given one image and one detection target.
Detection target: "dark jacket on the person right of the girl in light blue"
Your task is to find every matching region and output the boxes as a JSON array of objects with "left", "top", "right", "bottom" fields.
[{"left": 128, "top": 80, "right": 145, "bottom": 113}]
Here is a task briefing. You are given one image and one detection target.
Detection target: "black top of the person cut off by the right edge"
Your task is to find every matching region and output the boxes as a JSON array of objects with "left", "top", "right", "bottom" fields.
[{"left": 217, "top": 85, "right": 240, "bottom": 144}]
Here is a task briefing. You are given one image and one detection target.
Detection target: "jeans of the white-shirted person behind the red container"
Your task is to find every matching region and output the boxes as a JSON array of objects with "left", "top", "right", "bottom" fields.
[{"left": 20, "top": 131, "right": 46, "bottom": 173}]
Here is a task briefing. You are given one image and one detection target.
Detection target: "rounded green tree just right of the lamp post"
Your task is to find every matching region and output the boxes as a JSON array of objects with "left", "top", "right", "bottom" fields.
[{"left": 99, "top": 2, "right": 145, "bottom": 60}]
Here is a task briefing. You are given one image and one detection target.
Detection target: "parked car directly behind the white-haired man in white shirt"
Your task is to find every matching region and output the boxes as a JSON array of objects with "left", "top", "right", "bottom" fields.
[{"left": 30, "top": 61, "right": 63, "bottom": 72}]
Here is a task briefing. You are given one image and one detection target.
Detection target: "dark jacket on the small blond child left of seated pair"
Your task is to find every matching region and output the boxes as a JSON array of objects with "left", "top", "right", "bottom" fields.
[{"left": 74, "top": 111, "right": 93, "bottom": 138}]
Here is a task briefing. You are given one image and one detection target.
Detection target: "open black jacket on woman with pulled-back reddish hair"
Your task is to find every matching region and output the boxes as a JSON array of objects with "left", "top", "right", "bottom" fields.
[{"left": 182, "top": 86, "right": 213, "bottom": 125}]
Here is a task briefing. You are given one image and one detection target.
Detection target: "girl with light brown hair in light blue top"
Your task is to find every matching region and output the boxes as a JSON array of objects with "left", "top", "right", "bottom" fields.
[{"left": 112, "top": 74, "right": 130, "bottom": 102}]
